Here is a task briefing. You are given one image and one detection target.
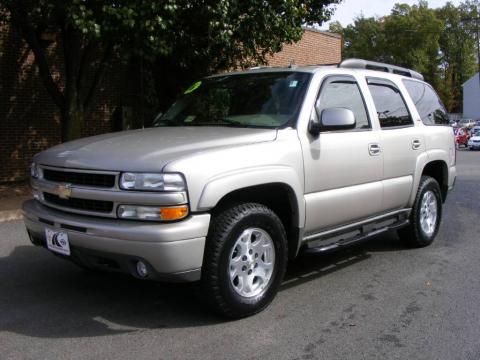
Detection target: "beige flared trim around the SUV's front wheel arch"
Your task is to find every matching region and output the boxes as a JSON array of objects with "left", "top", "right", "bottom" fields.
[{"left": 198, "top": 165, "right": 305, "bottom": 228}]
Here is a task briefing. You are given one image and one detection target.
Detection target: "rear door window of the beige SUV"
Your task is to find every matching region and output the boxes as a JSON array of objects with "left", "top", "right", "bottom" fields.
[{"left": 368, "top": 79, "right": 413, "bottom": 128}]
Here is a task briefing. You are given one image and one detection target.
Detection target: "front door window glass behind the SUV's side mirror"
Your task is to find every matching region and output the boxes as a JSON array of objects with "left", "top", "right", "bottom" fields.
[{"left": 316, "top": 80, "right": 370, "bottom": 129}]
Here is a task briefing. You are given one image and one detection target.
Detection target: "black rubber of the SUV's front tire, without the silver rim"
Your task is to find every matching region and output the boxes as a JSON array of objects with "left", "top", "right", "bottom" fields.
[{"left": 198, "top": 203, "right": 288, "bottom": 318}]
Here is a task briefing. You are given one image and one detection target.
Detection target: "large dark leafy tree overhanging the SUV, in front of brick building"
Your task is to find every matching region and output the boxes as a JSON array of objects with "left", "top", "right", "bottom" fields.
[{"left": 0, "top": 0, "right": 340, "bottom": 140}]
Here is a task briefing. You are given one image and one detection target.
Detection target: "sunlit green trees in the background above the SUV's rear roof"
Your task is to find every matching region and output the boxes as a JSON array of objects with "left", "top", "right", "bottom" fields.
[{"left": 330, "top": 0, "right": 478, "bottom": 112}]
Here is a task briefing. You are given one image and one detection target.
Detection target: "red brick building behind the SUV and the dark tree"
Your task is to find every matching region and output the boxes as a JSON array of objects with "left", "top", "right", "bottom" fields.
[{"left": 0, "top": 22, "right": 342, "bottom": 183}]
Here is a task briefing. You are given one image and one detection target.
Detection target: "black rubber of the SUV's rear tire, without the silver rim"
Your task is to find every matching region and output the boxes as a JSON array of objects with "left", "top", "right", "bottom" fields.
[{"left": 398, "top": 176, "right": 442, "bottom": 248}]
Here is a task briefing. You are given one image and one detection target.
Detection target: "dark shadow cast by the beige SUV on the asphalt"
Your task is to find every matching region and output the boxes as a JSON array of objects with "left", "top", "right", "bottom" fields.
[{"left": 0, "top": 231, "right": 405, "bottom": 338}]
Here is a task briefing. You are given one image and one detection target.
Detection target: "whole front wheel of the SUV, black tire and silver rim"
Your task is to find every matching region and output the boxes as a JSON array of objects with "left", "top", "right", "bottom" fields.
[{"left": 200, "top": 203, "right": 288, "bottom": 318}]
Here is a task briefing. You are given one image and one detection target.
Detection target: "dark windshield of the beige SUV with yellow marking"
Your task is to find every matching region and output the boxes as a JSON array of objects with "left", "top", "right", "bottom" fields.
[{"left": 153, "top": 72, "right": 311, "bottom": 128}]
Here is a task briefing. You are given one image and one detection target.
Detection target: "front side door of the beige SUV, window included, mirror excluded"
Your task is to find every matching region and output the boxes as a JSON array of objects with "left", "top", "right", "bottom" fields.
[{"left": 302, "top": 75, "right": 383, "bottom": 236}]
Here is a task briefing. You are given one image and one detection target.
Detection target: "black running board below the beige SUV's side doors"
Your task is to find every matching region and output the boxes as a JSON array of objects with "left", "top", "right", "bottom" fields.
[{"left": 302, "top": 209, "right": 410, "bottom": 254}]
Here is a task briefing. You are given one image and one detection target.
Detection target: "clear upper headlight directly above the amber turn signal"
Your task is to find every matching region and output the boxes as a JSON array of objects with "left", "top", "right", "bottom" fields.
[{"left": 120, "top": 173, "right": 186, "bottom": 191}]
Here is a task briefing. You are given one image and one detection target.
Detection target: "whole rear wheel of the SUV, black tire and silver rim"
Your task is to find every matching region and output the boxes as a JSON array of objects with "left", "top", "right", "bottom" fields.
[{"left": 398, "top": 176, "right": 442, "bottom": 247}]
